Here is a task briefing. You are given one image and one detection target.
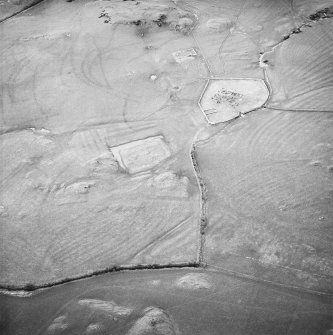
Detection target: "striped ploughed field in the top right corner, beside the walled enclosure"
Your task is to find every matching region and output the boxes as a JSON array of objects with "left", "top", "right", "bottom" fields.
[{"left": 260, "top": 7, "right": 333, "bottom": 112}]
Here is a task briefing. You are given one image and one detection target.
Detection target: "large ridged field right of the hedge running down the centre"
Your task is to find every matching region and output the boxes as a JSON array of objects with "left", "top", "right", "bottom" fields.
[{"left": 198, "top": 111, "right": 333, "bottom": 292}]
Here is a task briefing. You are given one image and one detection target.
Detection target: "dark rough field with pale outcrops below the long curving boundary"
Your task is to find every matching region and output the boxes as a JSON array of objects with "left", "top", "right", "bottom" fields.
[{"left": 1, "top": 269, "right": 332, "bottom": 335}]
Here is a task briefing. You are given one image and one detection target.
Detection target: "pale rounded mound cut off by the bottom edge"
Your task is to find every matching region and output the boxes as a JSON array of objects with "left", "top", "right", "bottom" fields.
[{"left": 127, "top": 307, "right": 180, "bottom": 335}]
